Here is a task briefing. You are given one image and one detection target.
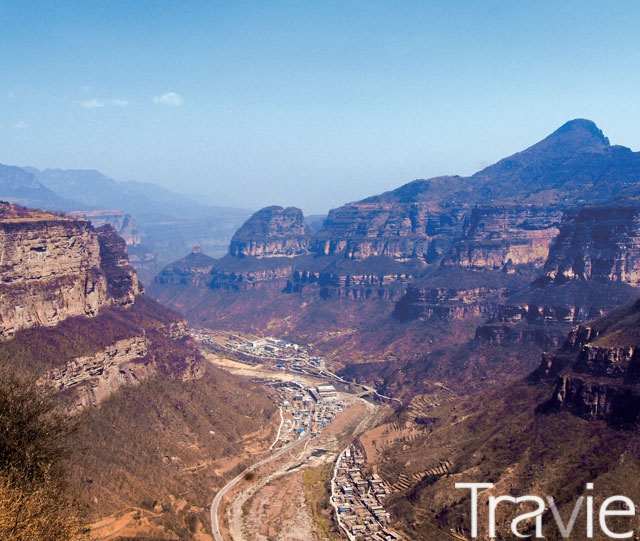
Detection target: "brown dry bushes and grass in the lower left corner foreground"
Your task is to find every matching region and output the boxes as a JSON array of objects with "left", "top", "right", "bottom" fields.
[{"left": 0, "top": 367, "right": 85, "bottom": 541}]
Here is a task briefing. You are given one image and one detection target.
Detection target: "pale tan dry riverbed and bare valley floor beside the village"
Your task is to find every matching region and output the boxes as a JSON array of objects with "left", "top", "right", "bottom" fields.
[{"left": 207, "top": 346, "right": 389, "bottom": 541}]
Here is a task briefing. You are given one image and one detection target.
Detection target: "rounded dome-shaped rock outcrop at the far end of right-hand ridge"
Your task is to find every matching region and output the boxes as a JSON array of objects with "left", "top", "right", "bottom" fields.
[{"left": 229, "top": 206, "right": 311, "bottom": 258}]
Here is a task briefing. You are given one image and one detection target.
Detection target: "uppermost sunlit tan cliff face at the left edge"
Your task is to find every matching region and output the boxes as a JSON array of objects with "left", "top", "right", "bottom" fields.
[{"left": 0, "top": 204, "right": 139, "bottom": 338}]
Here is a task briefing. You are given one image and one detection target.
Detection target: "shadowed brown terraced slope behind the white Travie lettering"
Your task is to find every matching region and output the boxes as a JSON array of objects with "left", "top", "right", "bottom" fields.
[{"left": 363, "top": 303, "right": 640, "bottom": 540}]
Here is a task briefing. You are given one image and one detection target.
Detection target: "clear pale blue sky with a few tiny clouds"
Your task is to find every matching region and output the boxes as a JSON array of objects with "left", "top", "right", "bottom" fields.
[{"left": 0, "top": 0, "right": 640, "bottom": 214}]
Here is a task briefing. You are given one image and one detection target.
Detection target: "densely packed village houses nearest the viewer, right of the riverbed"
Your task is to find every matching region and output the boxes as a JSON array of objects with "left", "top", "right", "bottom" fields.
[{"left": 331, "top": 445, "right": 403, "bottom": 541}]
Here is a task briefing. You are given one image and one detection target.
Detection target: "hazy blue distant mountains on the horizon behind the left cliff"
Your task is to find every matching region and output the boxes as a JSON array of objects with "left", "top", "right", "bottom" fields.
[{"left": 0, "top": 165, "right": 250, "bottom": 283}]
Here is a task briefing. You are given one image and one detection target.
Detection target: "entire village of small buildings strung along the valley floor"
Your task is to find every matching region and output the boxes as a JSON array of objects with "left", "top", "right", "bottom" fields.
[{"left": 191, "top": 329, "right": 404, "bottom": 541}]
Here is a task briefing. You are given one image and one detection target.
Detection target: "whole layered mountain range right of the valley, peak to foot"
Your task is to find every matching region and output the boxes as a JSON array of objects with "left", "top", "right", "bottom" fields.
[{"left": 145, "top": 119, "right": 640, "bottom": 541}]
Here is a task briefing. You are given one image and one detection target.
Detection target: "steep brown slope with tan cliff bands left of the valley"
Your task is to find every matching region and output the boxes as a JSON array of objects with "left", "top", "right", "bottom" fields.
[{"left": 0, "top": 204, "right": 274, "bottom": 539}]
